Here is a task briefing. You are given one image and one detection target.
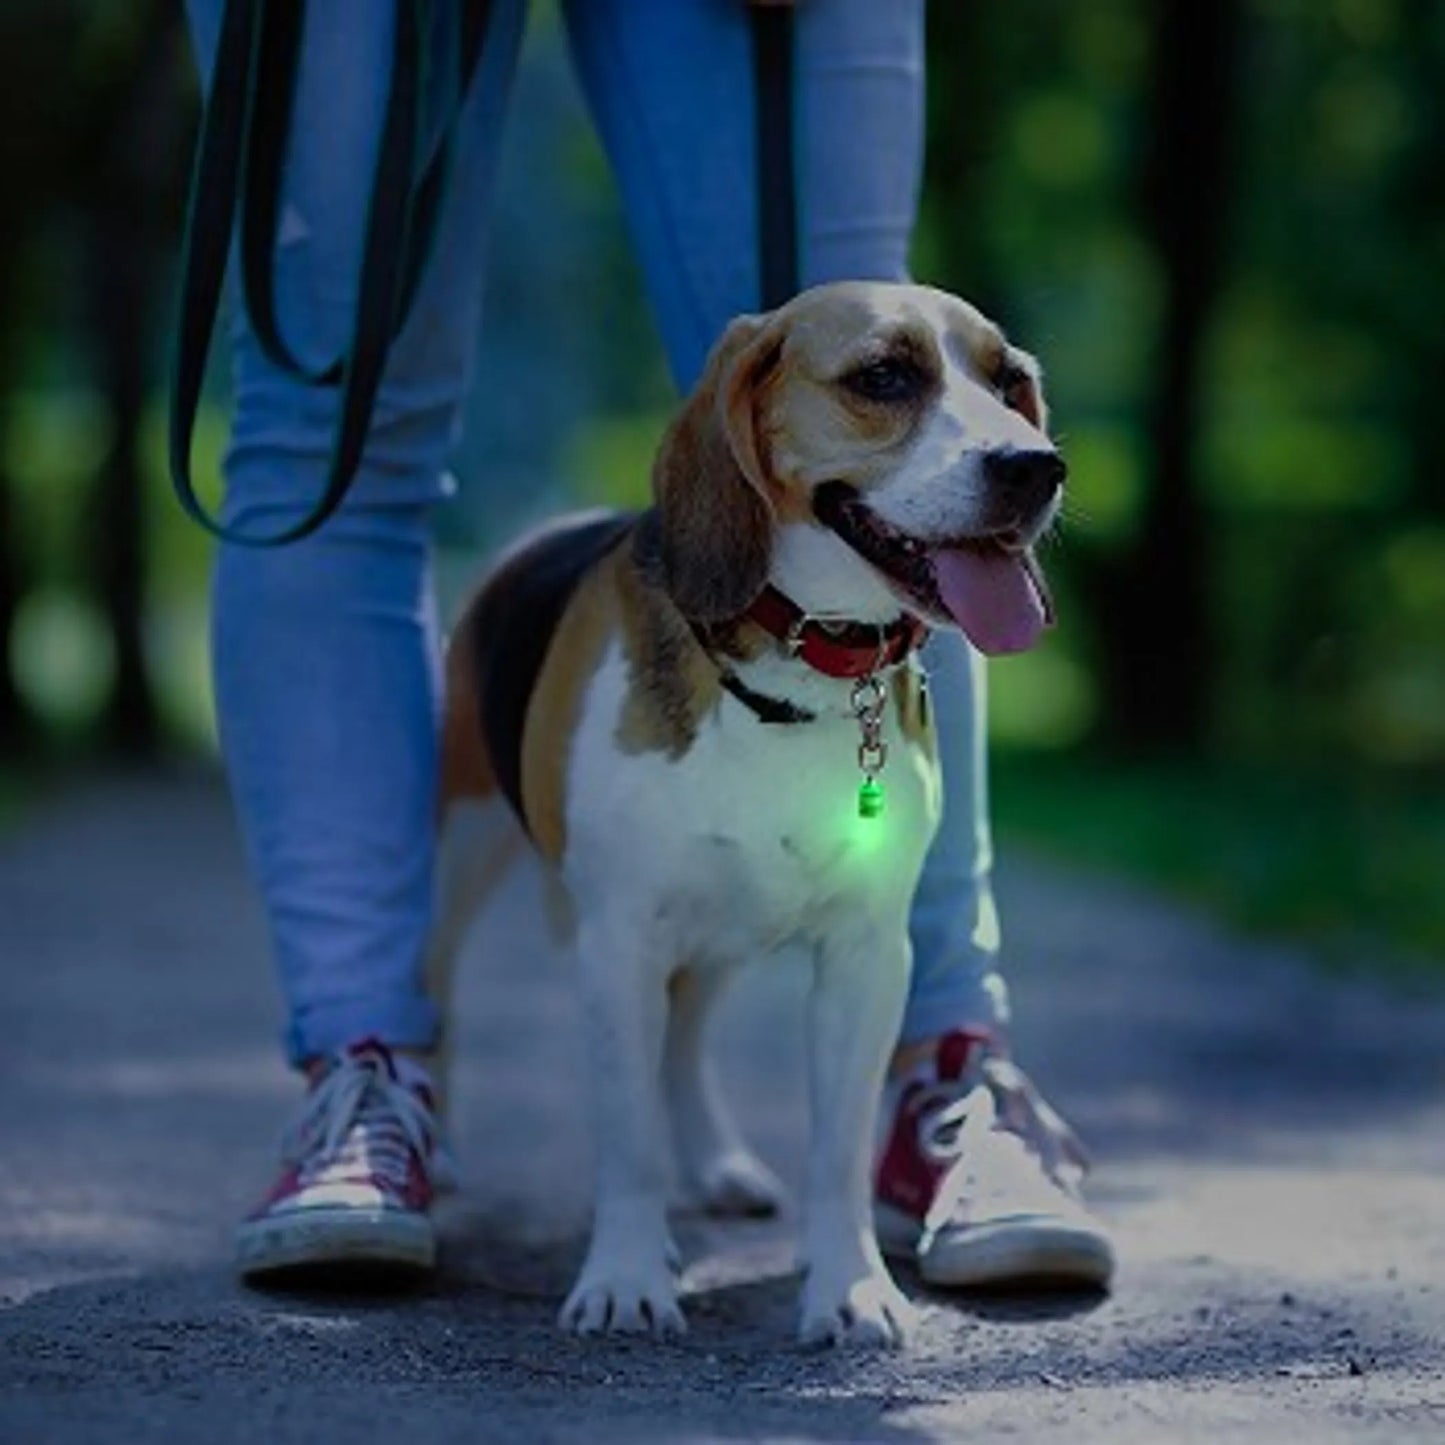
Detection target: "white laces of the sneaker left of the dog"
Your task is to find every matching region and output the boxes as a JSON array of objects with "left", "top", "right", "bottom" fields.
[{"left": 282, "top": 1058, "right": 436, "bottom": 1186}]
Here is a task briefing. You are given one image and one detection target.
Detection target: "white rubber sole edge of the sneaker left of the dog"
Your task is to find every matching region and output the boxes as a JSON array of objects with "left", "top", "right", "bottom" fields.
[{"left": 236, "top": 1207, "right": 436, "bottom": 1279}]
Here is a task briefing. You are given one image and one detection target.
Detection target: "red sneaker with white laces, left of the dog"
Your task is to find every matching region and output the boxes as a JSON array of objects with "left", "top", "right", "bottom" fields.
[{"left": 236, "top": 1039, "right": 438, "bottom": 1277}]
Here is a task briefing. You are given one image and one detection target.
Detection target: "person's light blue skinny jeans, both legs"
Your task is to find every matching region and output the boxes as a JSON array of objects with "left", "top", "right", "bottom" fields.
[{"left": 191, "top": 0, "right": 1007, "bottom": 1061}]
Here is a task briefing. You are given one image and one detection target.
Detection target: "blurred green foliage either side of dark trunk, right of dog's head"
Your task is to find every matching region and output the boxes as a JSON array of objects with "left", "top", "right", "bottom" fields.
[{"left": 920, "top": 0, "right": 1445, "bottom": 780}]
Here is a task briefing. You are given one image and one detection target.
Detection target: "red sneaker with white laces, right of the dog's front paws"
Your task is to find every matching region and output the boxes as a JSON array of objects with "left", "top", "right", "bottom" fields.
[{"left": 873, "top": 1030, "right": 1114, "bottom": 1289}]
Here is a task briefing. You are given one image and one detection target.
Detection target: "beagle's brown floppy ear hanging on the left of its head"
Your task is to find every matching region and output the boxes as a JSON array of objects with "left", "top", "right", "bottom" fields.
[{"left": 653, "top": 316, "right": 782, "bottom": 623}]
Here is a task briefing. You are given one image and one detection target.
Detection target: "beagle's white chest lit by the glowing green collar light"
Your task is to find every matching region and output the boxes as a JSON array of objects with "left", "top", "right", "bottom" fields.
[{"left": 564, "top": 657, "right": 939, "bottom": 955}]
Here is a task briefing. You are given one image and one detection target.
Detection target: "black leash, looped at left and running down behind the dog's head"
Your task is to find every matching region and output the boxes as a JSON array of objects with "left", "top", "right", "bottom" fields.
[{"left": 169, "top": 0, "right": 798, "bottom": 546}]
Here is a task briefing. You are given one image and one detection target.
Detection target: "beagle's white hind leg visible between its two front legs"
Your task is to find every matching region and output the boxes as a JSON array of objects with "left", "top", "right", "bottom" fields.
[{"left": 662, "top": 968, "right": 786, "bottom": 1217}]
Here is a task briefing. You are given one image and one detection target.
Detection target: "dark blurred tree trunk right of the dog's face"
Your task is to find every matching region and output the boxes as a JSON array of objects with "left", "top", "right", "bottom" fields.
[{"left": 1098, "top": 0, "right": 1238, "bottom": 751}]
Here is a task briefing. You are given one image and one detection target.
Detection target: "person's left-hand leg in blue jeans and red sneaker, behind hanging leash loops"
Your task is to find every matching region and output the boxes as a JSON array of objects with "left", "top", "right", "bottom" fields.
[{"left": 180, "top": 0, "right": 525, "bottom": 1270}]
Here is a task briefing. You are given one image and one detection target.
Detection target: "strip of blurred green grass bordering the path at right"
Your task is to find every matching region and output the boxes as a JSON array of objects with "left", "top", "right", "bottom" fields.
[{"left": 993, "top": 750, "right": 1445, "bottom": 972}]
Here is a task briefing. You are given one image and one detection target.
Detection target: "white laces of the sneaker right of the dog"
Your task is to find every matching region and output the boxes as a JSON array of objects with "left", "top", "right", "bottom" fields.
[{"left": 915, "top": 1055, "right": 1088, "bottom": 1230}]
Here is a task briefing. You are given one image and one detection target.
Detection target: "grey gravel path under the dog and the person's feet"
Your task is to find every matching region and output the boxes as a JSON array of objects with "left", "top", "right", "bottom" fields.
[{"left": 0, "top": 782, "right": 1445, "bottom": 1445}]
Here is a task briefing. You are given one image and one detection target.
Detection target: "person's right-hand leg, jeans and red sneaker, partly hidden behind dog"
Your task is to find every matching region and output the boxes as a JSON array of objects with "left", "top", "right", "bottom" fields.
[{"left": 566, "top": 0, "right": 1113, "bottom": 1283}]
